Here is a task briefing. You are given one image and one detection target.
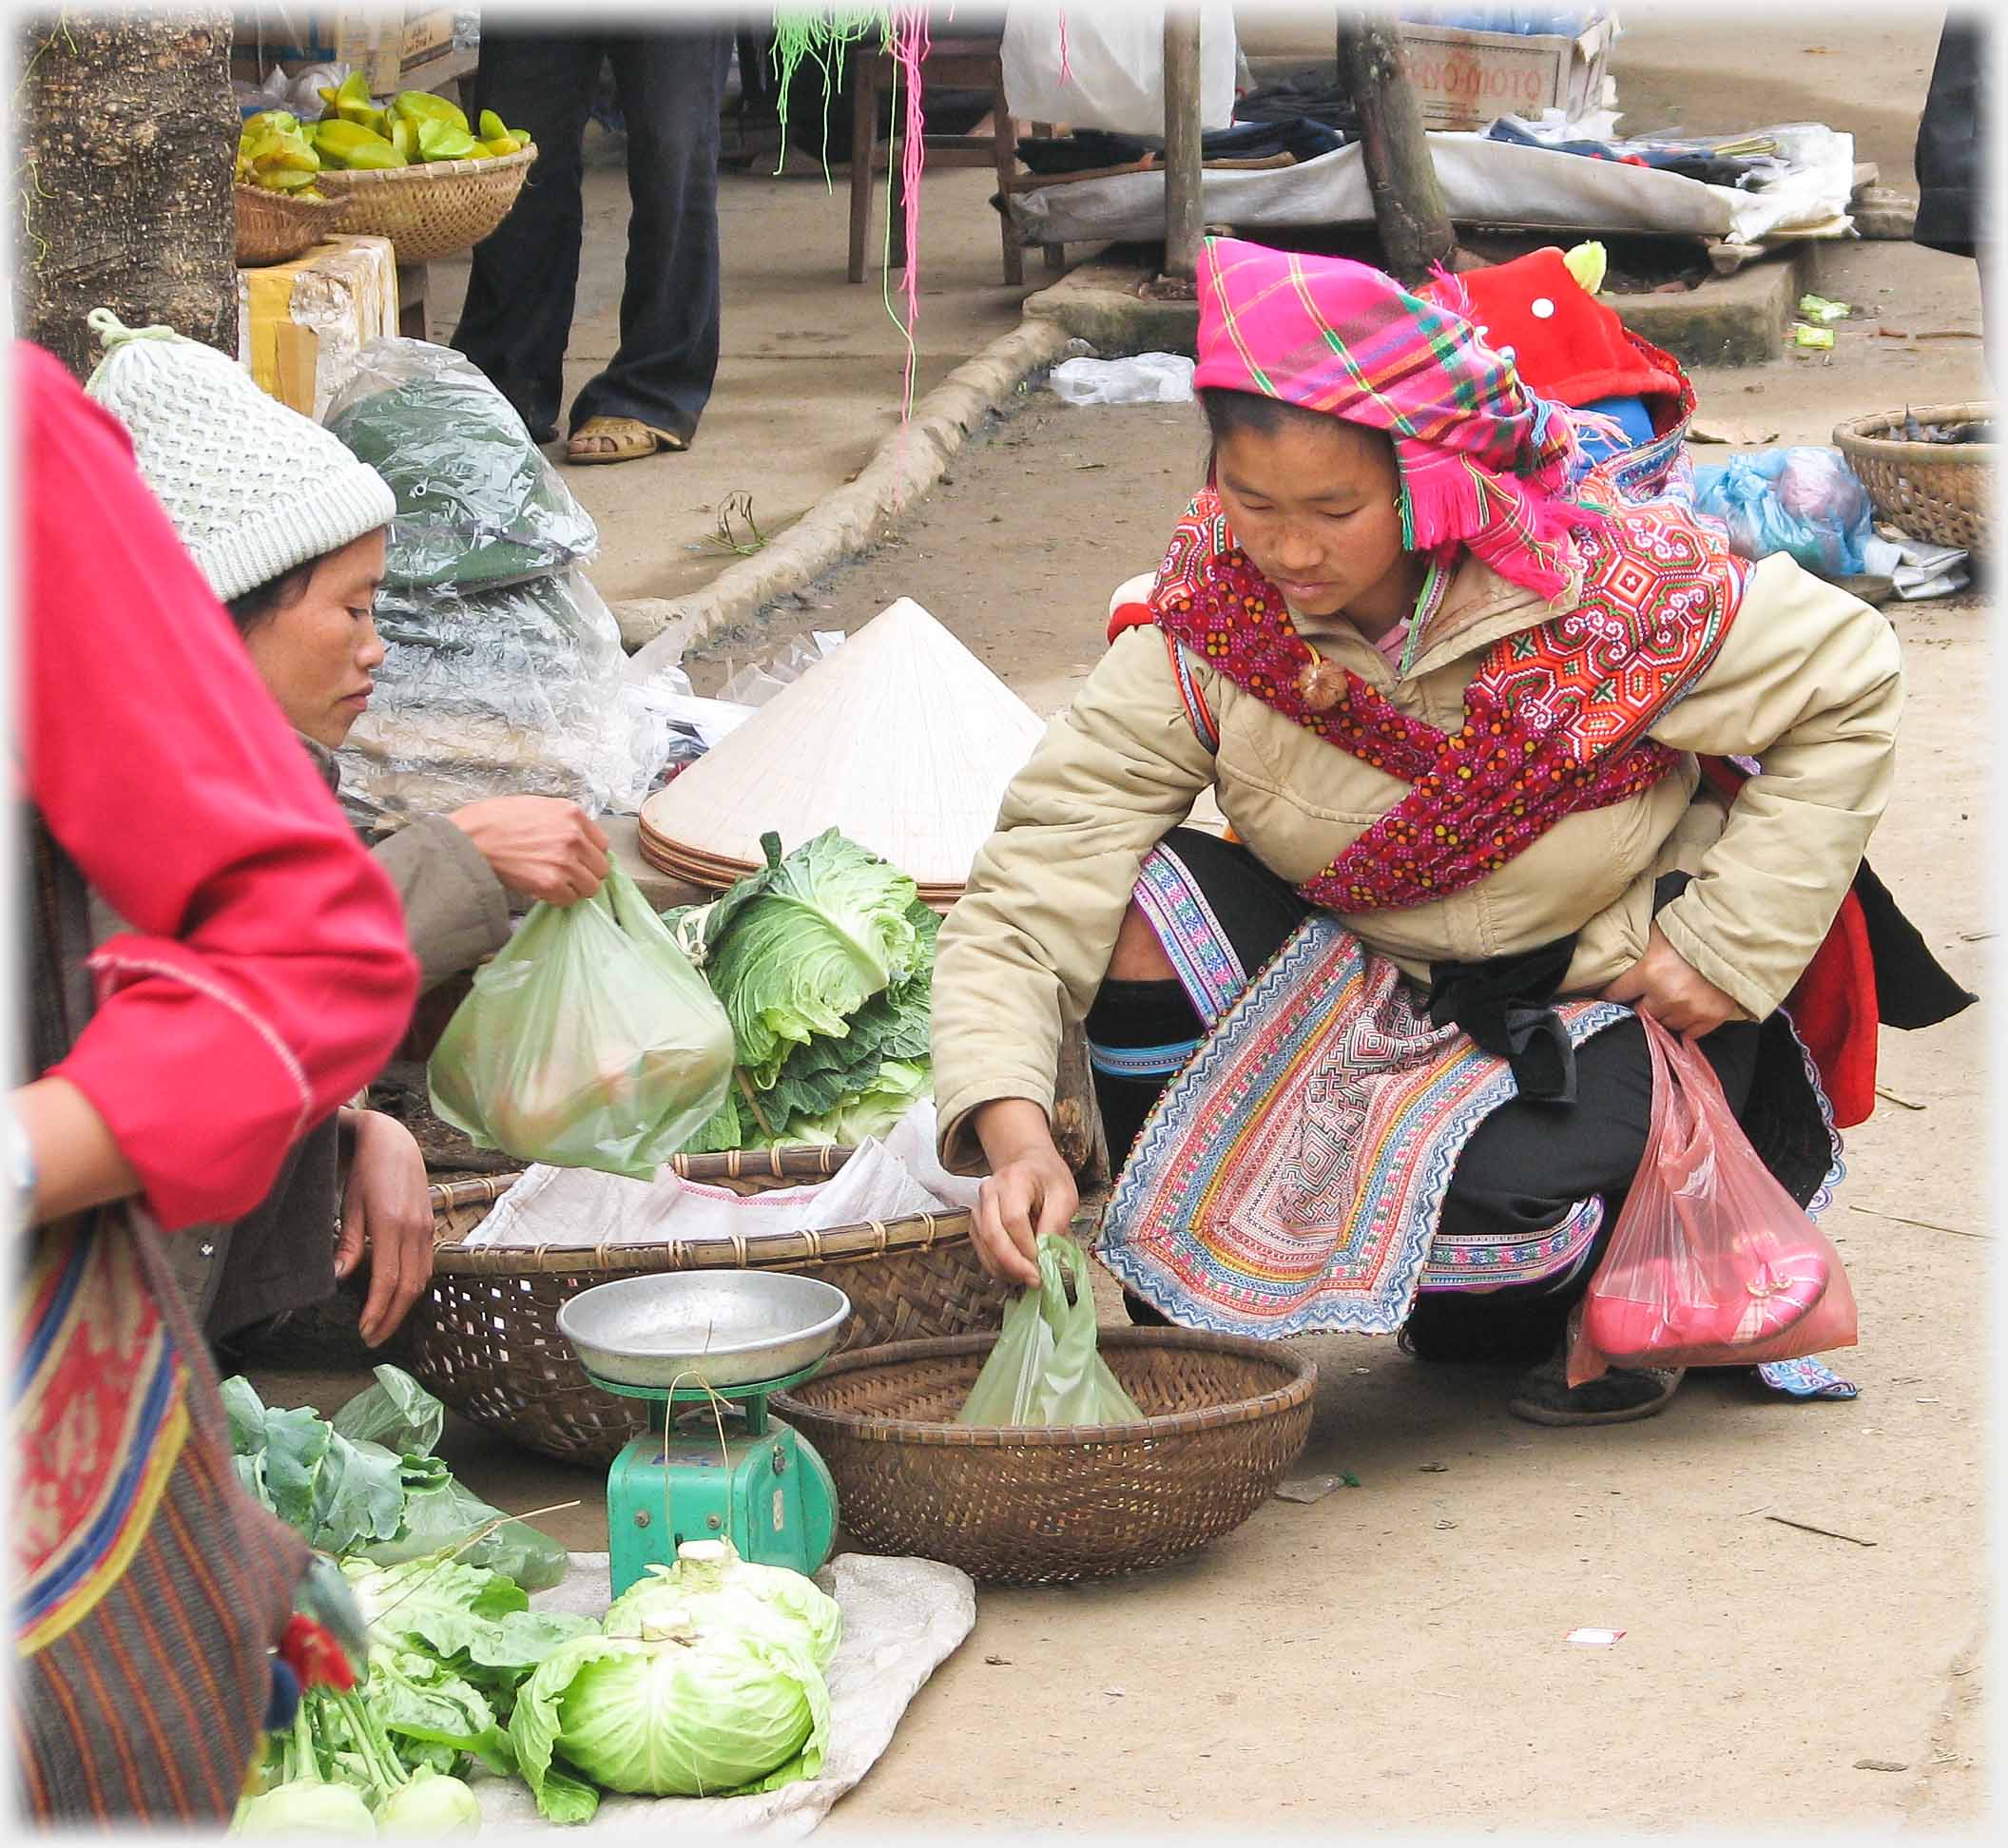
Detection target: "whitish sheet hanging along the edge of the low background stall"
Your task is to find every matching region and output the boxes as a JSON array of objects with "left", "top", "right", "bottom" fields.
[{"left": 1010, "top": 123, "right": 1855, "bottom": 243}]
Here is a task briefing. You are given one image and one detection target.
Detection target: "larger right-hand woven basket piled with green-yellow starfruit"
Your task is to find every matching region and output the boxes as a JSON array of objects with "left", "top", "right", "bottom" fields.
[{"left": 301, "top": 72, "right": 536, "bottom": 263}]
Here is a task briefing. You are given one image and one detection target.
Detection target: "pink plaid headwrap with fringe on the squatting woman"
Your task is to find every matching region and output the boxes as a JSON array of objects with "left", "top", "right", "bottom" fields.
[{"left": 1193, "top": 237, "right": 1602, "bottom": 597}]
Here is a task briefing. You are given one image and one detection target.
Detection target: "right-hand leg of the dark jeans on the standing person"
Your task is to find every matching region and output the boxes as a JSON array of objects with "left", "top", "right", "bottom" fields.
[{"left": 570, "top": 26, "right": 733, "bottom": 442}]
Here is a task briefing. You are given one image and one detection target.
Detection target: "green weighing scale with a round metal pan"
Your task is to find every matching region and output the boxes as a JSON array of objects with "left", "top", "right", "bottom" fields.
[{"left": 558, "top": 1269, "right": 851, "bottom": 1597}]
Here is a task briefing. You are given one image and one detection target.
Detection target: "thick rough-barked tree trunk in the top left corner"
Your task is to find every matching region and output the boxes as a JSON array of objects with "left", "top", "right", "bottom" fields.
[{"left": 14, "top": 6, "right": 237, "bottom": 377}]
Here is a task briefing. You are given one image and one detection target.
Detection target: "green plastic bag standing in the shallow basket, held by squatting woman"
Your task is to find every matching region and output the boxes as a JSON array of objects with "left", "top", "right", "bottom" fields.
[{"left": 956, "top": 1233, "right": 1143, "bottom": 1426}]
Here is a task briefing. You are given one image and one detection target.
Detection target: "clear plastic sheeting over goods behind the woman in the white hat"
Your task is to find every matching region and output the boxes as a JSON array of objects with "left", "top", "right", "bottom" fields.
[{"left": 327, "top": 339, "right": 670, "bottom": 832}]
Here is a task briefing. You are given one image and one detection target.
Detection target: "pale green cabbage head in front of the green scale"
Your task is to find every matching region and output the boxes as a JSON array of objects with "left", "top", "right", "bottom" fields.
[{"left": 510, "top": 1611, "right": 829, "bottom": 1822}]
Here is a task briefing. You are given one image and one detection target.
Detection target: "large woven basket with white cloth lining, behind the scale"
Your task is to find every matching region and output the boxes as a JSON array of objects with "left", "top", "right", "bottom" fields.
[{"left": 397, "top": 1149, "right": 1010, "bottom": 1464}]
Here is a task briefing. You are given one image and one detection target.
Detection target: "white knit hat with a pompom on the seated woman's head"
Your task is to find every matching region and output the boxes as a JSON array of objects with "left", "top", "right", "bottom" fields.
[{"left": 85, "top": 307, "right": 397, "bottom": 603}]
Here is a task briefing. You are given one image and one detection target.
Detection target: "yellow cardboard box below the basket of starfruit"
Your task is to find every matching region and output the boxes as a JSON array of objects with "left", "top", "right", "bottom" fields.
[{"left": 237, "top": 237, "right": 397, "bottom": 422}]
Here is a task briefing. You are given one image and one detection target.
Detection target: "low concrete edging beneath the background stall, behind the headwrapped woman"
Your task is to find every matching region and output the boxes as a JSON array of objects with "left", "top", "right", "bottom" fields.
[{"left": 1024, "top": 243, "right": 1805, "bottom": 366}]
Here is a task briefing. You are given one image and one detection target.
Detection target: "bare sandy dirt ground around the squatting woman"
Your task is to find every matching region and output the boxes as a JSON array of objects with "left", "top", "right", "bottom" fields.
[{"left": 259, "top": 4, "right": 1998, "bottom": 1840}]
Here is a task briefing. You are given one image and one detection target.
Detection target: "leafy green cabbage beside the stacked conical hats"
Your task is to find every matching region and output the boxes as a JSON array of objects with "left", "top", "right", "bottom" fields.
[{"left": 705, "top": 830, "right": 919, "bottom": 1088}]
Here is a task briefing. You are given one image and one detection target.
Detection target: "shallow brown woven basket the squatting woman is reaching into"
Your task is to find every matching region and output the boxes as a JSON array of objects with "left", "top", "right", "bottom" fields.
[{"left": 773, "top": 1328, "right": 1317, "bottom": 1585}]
